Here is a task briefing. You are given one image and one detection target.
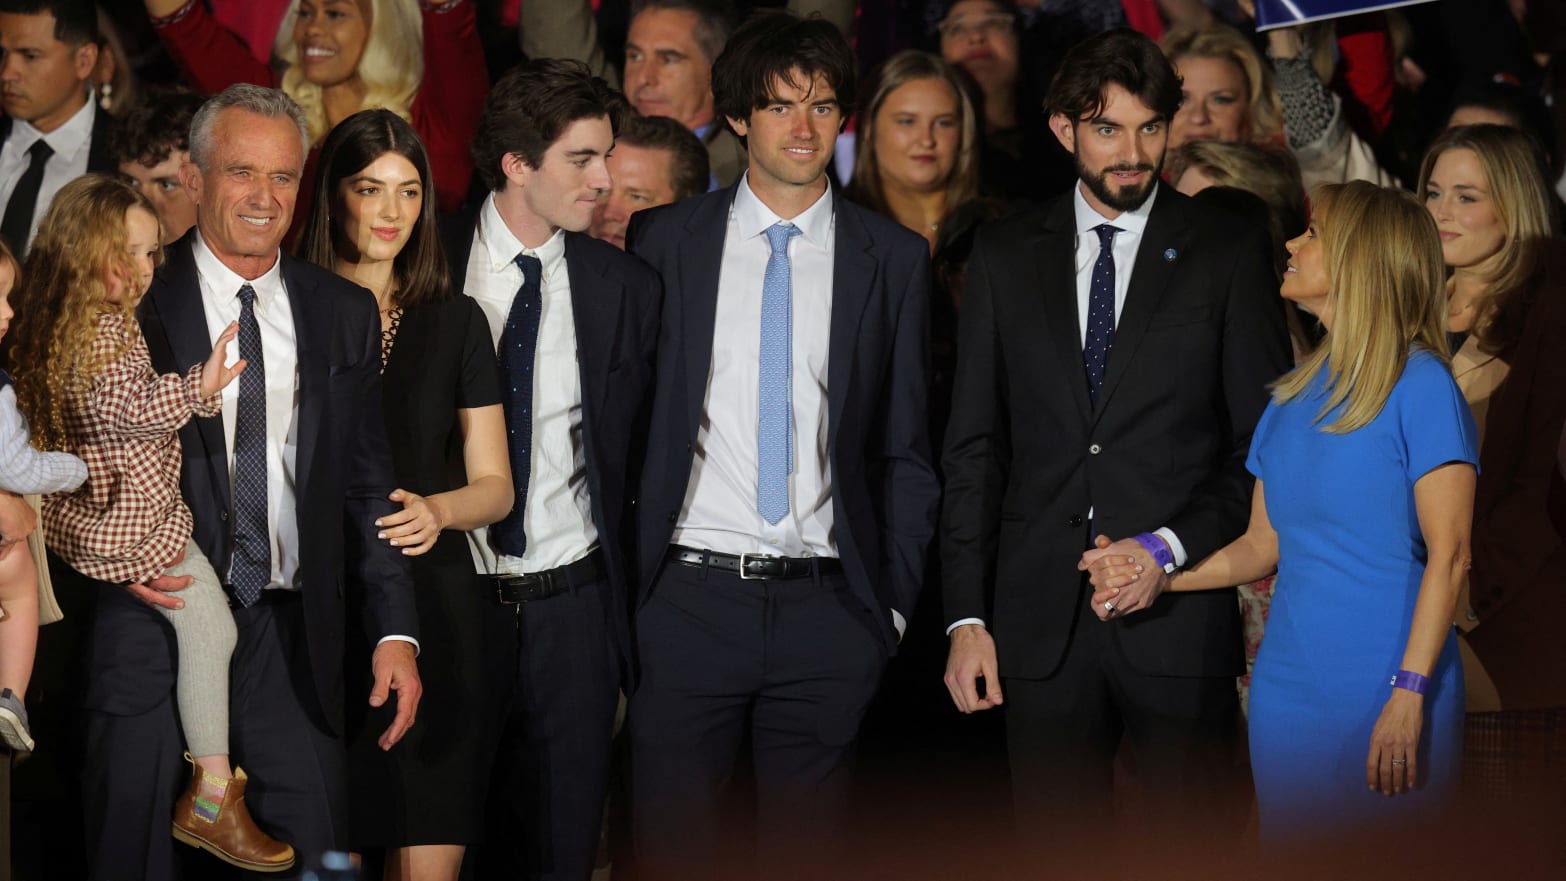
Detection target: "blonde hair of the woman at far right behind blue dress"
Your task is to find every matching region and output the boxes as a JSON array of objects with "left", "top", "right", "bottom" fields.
[{"left": 1417, "top": 125, "right": 1555, "bottom": 355}]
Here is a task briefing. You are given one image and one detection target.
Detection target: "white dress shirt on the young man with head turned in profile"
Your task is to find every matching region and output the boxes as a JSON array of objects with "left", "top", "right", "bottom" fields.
[{"left": 464, "top": 194, "right": 598, "bottom": 574}]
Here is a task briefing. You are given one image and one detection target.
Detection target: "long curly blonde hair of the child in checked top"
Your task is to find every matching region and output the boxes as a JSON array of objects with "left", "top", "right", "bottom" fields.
[{"left": 11, "top": 174, "right": 158, "bottom": 449}]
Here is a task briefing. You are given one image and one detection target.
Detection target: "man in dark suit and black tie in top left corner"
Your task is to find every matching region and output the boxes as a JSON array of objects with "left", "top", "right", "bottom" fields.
[{"left": 0, "top": 0, "right": 114, "bottom": 258}]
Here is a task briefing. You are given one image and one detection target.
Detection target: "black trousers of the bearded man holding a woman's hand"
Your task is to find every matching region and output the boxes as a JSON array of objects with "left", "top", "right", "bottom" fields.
[{"left": 1002, "top": 587, "right": 1243, "bottom": 848}]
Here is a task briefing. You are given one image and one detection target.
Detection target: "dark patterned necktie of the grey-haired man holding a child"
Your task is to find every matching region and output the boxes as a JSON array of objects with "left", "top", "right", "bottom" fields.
[{"left": 229, "top": 285, "right": 272, "bottom": 607}]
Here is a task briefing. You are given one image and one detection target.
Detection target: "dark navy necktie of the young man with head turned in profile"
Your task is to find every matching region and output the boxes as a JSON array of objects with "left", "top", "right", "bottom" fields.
[{"left": 493, "top": 254, "right": 543, "bottom": 557}]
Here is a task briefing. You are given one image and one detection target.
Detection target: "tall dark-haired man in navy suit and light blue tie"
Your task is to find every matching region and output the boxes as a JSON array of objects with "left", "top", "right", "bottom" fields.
[{"left": 628, "top": 16, "right": 940, "bottom": 876}]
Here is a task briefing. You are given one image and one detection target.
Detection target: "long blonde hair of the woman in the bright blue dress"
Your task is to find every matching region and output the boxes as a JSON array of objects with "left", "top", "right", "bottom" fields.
[{"left": 1273, "top": 180, "right": 1447, "bottom": 435}]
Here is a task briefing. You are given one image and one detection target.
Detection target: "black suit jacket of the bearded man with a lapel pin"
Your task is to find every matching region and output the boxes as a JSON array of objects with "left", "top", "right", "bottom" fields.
[{"left": 941, "top": 186, "right": 1290, "bottom": 679}]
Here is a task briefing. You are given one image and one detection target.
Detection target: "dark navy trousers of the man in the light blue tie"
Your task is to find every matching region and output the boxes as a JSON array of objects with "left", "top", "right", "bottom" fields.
[{"left": 630, "top": 563, "right": 886, "bottom": 878}]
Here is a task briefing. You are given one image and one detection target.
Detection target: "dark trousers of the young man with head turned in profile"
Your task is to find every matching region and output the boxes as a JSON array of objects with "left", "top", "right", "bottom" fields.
[{"left": 476, "top": 577, "right": 620, "bottom": 881}]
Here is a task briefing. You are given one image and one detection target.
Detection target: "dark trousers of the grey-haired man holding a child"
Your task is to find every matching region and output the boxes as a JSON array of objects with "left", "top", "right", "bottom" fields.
[{"left": 76, "top": 573, "right": 348, "bottom": 881}]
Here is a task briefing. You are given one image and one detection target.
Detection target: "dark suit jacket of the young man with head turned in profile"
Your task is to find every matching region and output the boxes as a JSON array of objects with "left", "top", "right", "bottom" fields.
[{"left": 442, "top": 203, "right": 662, "bottom": 662}]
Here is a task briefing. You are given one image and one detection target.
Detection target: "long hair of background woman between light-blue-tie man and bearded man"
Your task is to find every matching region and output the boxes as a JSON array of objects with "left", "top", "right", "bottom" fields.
[{"left": 850, "top": 49, "right": 979, "bottom": 216}]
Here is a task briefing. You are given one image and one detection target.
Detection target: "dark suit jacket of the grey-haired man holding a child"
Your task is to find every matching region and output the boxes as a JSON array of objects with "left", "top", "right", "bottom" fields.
[{"left": 136, "top": 230, "right": 418, "bottom": 732}]
